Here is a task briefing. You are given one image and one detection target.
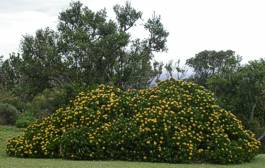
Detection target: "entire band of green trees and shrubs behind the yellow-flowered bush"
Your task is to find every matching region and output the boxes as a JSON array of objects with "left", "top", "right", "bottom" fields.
[{"left": 0, "top": 2, "right": 265, "bottom": 140}]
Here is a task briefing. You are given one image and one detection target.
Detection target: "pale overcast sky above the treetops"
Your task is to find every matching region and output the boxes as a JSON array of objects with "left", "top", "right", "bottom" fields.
[{"left": 0, "top": 0, "right": 265, "bottom": 62}]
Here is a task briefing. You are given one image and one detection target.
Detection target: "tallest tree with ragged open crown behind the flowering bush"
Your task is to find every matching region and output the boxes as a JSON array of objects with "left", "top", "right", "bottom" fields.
[{"left": 58, "top": 2, "right": 168, "bottom": 88}]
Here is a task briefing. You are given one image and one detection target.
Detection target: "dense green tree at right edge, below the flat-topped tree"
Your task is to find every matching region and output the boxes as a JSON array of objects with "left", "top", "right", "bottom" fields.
[{"left": 207, "top": 59, "right": 265, "bottom": 130}]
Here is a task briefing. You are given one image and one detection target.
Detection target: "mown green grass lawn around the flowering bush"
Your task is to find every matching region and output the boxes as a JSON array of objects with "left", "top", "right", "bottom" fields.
[{"left": 0, "top": 126, "right": 265, "bottom": 168}]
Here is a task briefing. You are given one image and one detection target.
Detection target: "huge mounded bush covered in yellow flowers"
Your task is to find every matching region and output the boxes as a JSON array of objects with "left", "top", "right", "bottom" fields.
[{"left": 7, "top": 79, "right": 260, "bottom": 164}]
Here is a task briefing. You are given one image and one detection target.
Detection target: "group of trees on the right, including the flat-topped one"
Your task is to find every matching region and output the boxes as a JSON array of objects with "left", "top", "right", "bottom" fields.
[{"left": 187, "top": 50, "right": 265, "bottom": 142}]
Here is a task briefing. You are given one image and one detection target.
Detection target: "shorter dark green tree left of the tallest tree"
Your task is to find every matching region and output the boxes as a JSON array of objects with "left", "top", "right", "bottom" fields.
[{"left": 3, "top": 28, "right": 65, "bottom": 100}]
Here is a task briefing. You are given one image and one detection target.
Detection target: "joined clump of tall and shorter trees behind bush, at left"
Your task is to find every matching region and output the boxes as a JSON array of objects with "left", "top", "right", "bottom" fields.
[{"left": 1, "top": 2, "right": 168, "bottom": 100}]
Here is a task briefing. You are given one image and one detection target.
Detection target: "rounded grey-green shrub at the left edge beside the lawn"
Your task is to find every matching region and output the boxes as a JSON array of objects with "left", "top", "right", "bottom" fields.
[{"left": 0, "top": 103, "right": 18, "bottom": 125}]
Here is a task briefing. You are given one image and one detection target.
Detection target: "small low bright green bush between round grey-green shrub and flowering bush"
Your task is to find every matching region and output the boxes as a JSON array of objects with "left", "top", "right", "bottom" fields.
[{"left": 16, "top": 112, "right": 35, "bottom": 128}]
